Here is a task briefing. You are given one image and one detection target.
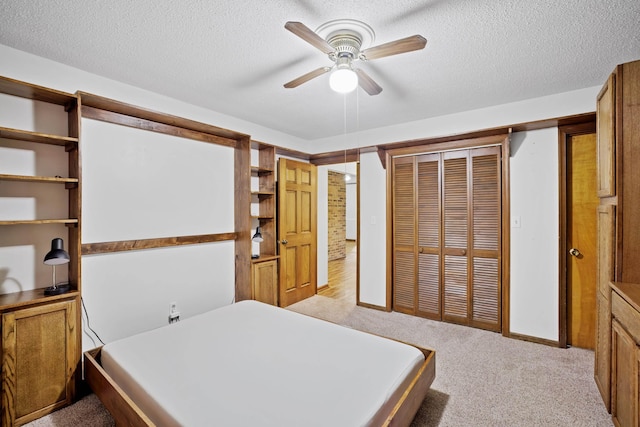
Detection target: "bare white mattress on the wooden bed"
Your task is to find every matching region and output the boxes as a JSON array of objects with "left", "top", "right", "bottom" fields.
[{"left": 102, "top": 301, "right": 424, "bottom": 427}]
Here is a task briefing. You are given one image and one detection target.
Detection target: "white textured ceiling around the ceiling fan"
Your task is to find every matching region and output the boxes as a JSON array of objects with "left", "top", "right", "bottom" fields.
[{"left": 0, "top": 0, "right": 640, "bottom": 140}]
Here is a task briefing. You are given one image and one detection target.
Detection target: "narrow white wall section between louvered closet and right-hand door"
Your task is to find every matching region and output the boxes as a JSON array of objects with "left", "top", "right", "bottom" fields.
[{"left": 510, "top": 128, "right": 560, "bottom": 341}]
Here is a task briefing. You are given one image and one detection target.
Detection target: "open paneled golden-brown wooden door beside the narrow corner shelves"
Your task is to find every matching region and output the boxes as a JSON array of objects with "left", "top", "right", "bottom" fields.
[{"left": 278, "top": 158, "right": 318, "bottom": 307}]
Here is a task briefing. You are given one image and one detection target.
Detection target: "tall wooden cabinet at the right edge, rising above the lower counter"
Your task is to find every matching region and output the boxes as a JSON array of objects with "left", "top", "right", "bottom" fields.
[{"left": 595, "top": 61, "right": 640, "bottom": 412}]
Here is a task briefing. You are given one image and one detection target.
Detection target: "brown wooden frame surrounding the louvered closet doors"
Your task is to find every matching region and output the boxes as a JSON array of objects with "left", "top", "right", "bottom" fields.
[{"left": 385, "top": 132, "right": 511, "bottom": 336}]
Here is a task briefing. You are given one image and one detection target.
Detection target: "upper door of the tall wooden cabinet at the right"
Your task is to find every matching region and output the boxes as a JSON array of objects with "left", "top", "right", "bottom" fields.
[{"left": 596, "top": 74, "right": 616, "bottom": 197}]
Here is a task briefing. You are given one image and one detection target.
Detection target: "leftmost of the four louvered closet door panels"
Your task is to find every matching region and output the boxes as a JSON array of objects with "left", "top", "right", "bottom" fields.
[{"left": 392, "top": 157, "right": 416, "bottom": 314}]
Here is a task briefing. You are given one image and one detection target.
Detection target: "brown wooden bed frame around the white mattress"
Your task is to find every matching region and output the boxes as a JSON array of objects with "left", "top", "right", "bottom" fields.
[{"left": 84, "top": 343, "right": 436, "bottom": 427}]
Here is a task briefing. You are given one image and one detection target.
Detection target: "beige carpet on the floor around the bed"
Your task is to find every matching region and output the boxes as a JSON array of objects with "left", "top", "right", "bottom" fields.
[{"left": 27, "top": 296, "right": 613, "bottom": 427}]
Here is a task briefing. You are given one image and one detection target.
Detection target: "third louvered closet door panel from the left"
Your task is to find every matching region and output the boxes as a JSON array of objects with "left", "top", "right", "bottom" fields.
[{"left": 442, "top": 150, "right": 470, "bottom": 324}]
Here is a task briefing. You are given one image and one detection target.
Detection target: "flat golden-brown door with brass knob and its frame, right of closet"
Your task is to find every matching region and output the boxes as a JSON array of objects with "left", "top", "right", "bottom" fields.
[{"left": 559, "top": 123, "right": 599, "bottom": 350}]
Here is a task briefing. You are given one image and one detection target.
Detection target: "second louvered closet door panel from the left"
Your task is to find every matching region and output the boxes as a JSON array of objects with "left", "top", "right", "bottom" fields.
[{"left": 416, "top": 153, "right": 441, "bottom": 320}]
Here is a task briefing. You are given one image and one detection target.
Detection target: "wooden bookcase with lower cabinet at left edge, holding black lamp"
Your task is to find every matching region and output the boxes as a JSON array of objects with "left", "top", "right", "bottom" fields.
[{"left": 0, "top": 77, "right": 81, "bottom": 426}]
